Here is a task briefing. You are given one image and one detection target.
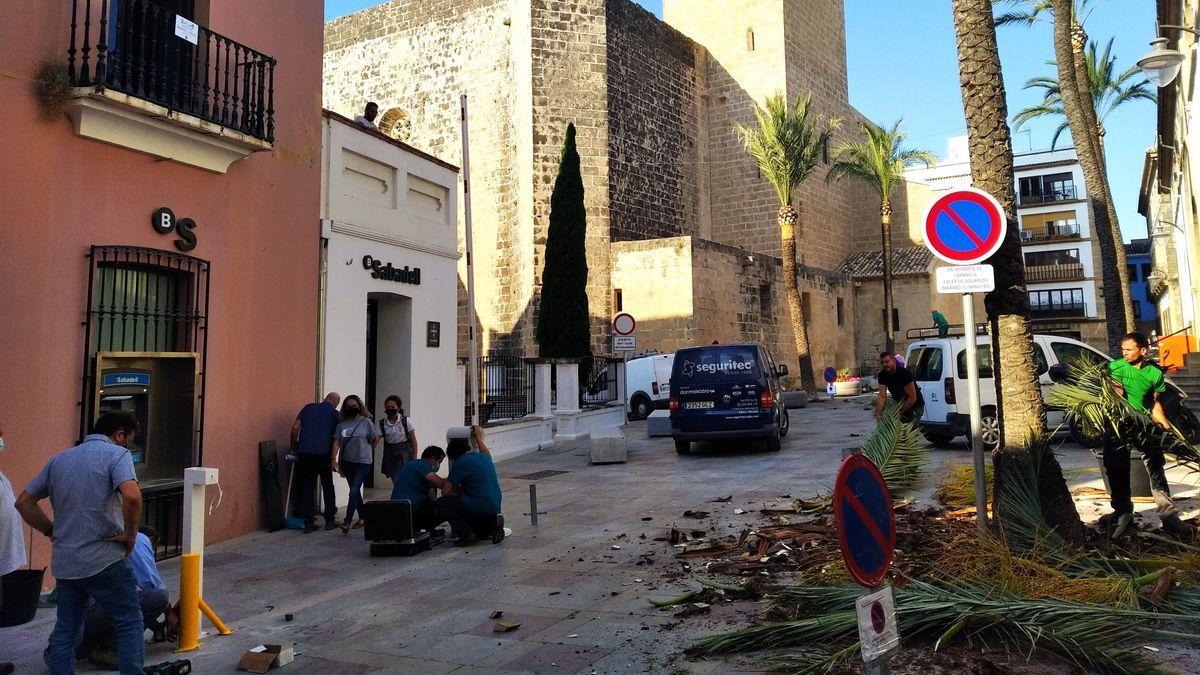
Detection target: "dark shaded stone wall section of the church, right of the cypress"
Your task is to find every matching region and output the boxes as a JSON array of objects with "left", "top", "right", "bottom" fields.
[{"left": 606, "top": 0, "right": 708, "bottom": 241}]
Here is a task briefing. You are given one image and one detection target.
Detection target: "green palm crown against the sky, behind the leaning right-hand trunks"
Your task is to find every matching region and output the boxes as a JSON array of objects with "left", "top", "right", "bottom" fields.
[{"left": 1013, "top": 37, "right": 1158, "bottom": 150}]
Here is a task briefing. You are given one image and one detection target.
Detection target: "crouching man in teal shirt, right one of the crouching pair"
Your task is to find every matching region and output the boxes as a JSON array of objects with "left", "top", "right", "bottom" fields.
[{"left": 437, "top": 426, "right": 504, "bottom": 546}]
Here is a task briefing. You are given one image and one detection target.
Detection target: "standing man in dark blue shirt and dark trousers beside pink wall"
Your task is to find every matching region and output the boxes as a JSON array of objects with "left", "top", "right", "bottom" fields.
[{"left": 292, "top": 392, "right": 342, "bottom": 534}]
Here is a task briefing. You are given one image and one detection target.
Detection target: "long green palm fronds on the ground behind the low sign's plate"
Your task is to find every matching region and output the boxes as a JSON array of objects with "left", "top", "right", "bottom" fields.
[{"left": 694, "top": 580, "right": 1200, "bottom": 673}]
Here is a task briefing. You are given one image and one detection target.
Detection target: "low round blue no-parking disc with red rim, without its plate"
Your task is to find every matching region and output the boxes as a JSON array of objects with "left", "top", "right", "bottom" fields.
[{"left": 833, "top": 453, "right": 896, "bottom": 587}]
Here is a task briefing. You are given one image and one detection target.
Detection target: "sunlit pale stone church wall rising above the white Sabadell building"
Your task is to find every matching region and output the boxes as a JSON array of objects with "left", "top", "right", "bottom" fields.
[{"left": 324, "top": 0, "right": 533, "bottom": 353}]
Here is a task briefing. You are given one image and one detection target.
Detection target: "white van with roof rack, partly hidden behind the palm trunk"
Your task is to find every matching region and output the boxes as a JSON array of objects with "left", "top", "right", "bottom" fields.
[{"left": 905, "top": 335, "right": 1112, "bottom": 448}]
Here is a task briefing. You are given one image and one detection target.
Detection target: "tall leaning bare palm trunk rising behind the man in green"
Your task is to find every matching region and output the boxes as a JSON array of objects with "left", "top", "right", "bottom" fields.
[{"left": 1052, "top": 10, "right": 1134, "bottom": 343}]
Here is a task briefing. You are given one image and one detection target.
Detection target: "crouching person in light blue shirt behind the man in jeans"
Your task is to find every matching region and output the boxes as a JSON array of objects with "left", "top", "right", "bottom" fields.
[{"left": 76, "top": 526, "right": 179, "bottom": 667}]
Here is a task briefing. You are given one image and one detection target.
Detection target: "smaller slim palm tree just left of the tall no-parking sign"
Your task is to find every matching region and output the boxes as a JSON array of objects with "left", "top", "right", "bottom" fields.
[{"left": 826, "top": 120, "right": 934, "bottom": 352}]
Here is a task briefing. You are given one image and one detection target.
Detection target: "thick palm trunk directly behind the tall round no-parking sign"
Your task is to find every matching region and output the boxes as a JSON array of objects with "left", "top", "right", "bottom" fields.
[{"left": 953, "top": 0, "right": 1082, "bottom": 538}]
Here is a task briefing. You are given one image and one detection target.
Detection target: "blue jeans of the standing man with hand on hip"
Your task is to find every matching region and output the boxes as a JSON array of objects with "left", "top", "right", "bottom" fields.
[{"left": 47, "top": 558, "right": 146, "bottom": 675}]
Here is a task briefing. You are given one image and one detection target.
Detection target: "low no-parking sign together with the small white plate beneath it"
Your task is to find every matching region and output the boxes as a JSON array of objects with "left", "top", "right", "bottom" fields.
[{"left": 833, "top": 452, "right": 900, "bottom": 674}]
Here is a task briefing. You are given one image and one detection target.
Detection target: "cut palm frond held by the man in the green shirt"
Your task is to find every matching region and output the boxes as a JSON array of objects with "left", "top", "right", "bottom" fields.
[{"left": 1046, "top": 359, "right": 1200, "bottom": 471}]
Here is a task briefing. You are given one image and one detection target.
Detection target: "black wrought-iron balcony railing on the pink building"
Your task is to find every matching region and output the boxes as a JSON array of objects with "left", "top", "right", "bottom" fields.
[{"left": 67, "top": 0, "right": 276, "bottom": 143}]
